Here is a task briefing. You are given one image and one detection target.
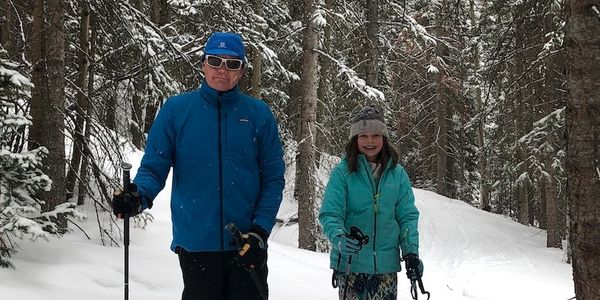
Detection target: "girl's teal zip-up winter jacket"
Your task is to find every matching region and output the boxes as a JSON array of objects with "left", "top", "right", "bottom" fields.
[{"left": 319, "top": 154, "right": 419, "bottom": 274}]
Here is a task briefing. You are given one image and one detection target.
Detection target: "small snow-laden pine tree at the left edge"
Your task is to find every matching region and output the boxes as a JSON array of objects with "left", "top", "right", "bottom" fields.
[{"left": 0, "top": 50, "right": 75, "bottom": 267}]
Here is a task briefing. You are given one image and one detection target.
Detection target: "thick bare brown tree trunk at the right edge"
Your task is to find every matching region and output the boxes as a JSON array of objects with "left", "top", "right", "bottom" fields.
[{"left": 565, "top": 0, "right": 600, "bottom": 300}]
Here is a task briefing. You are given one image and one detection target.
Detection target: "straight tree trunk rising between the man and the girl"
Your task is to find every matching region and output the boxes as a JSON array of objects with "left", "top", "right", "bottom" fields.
[{"left": 294, "top": 0, "right": 320, "bottom": 251}]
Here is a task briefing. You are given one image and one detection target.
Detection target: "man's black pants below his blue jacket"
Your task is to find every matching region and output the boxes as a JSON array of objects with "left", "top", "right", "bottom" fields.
[{"left": 177, "top": 248, "right": 268, "bottom": 300}]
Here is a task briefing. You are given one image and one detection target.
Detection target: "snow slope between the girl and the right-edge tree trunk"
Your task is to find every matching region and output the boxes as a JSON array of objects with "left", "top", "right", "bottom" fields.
[{"left": 415, "top": 190, "right": 574, "bottom": 300}]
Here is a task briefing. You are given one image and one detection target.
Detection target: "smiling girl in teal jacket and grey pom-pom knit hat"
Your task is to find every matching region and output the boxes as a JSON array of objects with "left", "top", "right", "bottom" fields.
[{"left": 319, "top": 107, "right": 423, "bottom": 300}]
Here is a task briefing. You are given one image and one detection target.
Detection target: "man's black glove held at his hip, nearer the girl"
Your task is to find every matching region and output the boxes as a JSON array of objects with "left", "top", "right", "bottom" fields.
[{"left": 234, "top": 225, "right": 269, "bottom": 270}]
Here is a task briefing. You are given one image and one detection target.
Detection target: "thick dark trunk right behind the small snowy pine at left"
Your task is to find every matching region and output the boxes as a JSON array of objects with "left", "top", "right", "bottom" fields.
[{"left": 29, "top": 0, "right": 67, "bottom": 231}]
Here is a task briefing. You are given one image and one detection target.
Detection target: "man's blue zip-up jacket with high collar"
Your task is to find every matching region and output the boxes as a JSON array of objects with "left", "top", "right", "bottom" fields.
[{"left": 134, "top": 82, "right": 285, "bottom": 251}]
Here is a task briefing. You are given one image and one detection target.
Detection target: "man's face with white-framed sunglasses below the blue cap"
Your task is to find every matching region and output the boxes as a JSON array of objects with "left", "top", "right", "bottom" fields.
[{"left": 202, "top": 55, "right": 244, "bottom": 92}]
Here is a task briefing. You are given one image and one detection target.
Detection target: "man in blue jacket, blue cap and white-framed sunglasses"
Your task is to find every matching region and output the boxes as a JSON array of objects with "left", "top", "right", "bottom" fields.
[{"left": 113, "top": 32, "right": 284, "bottom": 300}]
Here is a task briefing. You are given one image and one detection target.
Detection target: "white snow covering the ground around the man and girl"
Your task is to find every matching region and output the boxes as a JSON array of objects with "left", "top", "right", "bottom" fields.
[{"left": 0, "top": 153, "right": 574, "bottom": 300}]
